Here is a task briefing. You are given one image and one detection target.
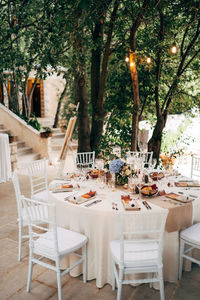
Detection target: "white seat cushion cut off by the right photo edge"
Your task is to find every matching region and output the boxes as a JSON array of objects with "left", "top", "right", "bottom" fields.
[{"left": 180, "top": 223, "right": 200, "bottom": 246}]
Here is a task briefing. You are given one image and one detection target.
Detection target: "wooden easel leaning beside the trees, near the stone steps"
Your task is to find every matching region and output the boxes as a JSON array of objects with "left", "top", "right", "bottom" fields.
[{"left": 57, "top": 103, "right": 79, "bottom": 177}]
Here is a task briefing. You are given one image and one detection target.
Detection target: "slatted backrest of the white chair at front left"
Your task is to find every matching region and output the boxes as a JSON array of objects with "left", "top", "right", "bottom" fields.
[{"left": 22, "top": 197, "right": 59, "bottom": 257}]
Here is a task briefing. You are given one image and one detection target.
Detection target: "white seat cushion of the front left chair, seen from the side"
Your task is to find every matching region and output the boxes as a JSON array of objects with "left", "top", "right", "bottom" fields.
[{"left": 34, "top": 227, "right": 87, "bottom": 257}]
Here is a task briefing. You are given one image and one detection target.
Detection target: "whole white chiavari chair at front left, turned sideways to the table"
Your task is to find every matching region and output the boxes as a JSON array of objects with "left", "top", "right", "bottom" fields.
[{"left": 22, "top": 197, "right": 87, "bottom": 300}]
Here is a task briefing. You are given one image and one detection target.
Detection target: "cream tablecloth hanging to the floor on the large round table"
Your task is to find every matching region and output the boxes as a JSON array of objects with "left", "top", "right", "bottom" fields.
[{"left": 49, "top": 182, "right": 200, "bottom": 288}]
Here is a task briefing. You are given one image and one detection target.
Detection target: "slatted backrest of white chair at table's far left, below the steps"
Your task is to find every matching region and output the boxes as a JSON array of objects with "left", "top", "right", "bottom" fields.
[{"left": 27, "top": 158, "right": 48, "bottom": 197}]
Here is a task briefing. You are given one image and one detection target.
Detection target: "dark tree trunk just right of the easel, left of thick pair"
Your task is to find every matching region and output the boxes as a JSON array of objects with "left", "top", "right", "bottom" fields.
[{"left": 74, "top": 71, "right": 91, "bottom": 152}]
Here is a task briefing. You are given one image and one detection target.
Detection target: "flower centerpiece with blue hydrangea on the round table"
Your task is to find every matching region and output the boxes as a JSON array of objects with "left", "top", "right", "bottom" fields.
[{"left": 109, "top": 158, "right": 131, "bottom": 185}]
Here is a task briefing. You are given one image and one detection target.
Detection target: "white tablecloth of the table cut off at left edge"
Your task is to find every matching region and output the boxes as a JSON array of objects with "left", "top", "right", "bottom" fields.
[{"left": 0, "top": 133, "right": 12, "bottom": 183}]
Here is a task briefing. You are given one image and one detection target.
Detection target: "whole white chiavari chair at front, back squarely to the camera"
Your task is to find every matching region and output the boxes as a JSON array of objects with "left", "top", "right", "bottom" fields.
[{"left": 110, "top": 209, "right": 168, "bottom": 300}]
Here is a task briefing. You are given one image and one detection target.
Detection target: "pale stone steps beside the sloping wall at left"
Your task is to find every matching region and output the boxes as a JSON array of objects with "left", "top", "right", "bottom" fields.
[{"left": 0, "top": 124, "right": 40, "bottom": 168}]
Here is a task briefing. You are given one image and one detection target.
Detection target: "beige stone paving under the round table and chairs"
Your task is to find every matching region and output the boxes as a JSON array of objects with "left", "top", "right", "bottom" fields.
[{"left": 0, "top": 166, "right": 200, "bottom": 300}]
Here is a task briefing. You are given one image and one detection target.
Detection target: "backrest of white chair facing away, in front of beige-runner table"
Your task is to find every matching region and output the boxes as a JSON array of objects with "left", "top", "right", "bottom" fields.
[{"left": 119, "top": 209, "right": 168, "bottom": 266}]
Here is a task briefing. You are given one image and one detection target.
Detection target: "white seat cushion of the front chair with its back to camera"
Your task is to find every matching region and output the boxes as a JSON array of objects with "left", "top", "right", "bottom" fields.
[{"left": 110, "top": 240, "right": 161, "bottom": 268}]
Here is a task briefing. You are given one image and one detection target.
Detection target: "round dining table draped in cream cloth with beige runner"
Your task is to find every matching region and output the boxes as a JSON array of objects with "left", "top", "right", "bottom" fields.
[{"left": 49, "top": 179, "right": 200, "bottom": 288}]
